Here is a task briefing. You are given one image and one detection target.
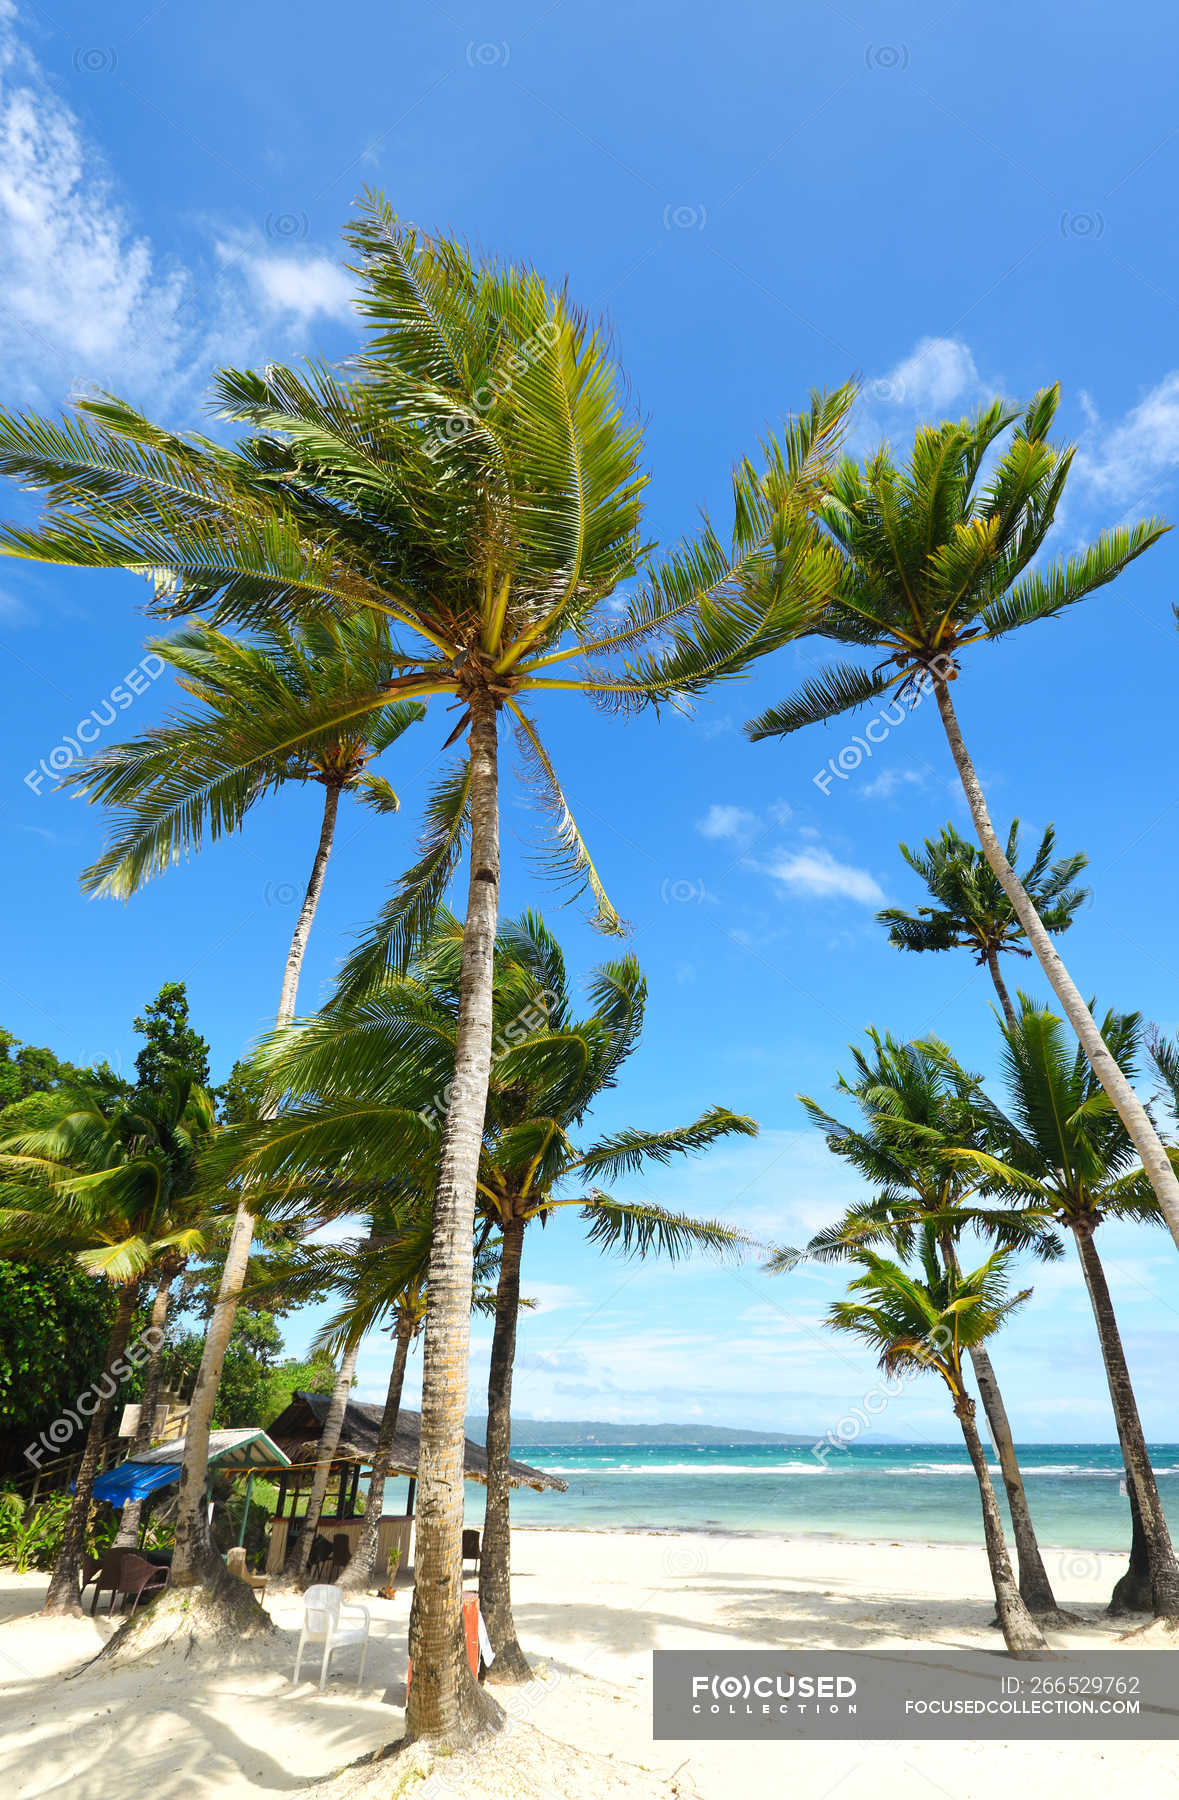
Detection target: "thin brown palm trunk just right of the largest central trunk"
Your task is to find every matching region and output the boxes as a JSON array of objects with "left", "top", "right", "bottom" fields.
[{"left": 479, "top": 1213, "right": 533, "bottom": 1683}]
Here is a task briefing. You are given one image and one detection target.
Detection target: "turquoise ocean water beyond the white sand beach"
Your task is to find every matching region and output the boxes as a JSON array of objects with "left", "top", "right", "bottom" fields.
[{"left": 489, "top": 1444, "right": 1179, "bottom": 1550}]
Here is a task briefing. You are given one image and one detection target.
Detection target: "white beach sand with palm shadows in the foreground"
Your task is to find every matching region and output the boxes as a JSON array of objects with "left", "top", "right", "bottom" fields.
[{"left": 0, "top": 1530, "right": 1179, "bottom": 1800}]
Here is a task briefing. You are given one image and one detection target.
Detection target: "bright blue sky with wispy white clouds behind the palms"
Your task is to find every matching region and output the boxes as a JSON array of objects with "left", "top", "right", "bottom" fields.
[{"left": 0, "top": 0, "right": 1179, "bottom": 1442}]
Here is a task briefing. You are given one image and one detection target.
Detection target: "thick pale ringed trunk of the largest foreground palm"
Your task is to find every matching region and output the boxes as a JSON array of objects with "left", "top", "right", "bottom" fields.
[{"left": 405, "top": 688, "right": 502, "bottom": 1750}]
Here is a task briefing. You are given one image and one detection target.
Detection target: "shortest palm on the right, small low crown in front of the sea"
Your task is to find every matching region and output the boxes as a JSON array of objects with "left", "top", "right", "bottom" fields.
[{"left": 826, "top": 1224, "right": 1048, "bottom": 1660}]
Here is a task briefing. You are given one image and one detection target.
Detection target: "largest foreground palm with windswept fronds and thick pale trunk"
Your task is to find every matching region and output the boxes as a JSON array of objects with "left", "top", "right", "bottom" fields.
[{"left": 0, "top": 198, "right": 850, "bottom": 1746}]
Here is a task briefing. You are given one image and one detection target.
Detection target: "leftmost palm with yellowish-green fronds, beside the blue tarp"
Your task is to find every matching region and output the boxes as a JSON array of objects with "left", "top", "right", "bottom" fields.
[{"left": 0, "top": 1076, "right": 216, "bottom": 1613}]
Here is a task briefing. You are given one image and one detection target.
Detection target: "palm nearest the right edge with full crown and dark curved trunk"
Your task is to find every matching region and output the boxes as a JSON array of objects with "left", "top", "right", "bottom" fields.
[{"left": 949, "top": 995, "right": 1179, "bottom": 1618}]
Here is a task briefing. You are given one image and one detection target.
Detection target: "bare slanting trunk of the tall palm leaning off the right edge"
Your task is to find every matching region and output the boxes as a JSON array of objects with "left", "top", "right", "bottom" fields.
[{"left": 934, "top": 675, "right": 1179, "bottom": 1246}]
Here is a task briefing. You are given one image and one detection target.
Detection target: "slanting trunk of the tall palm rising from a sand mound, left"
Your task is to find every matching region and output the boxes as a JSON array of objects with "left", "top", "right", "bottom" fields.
[{"left": 173, "top": 787, "right": 340, "bottom": 1588}]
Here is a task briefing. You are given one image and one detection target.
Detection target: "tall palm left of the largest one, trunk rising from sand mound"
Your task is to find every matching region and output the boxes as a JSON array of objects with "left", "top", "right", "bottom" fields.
[{"left": 58, "top": 612, "right": 425, "bottom": 1582}]
